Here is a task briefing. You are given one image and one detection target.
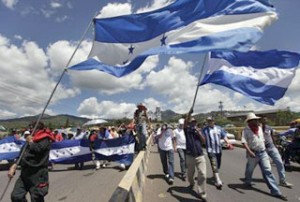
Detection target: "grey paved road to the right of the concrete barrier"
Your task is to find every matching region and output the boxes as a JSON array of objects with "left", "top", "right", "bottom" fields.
[{"left": 143, "top": 145, "right": 300, "bottom": 202}]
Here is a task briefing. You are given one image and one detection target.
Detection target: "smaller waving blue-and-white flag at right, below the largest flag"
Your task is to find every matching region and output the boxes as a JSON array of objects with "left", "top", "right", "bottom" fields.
[{"left": 199, "top": 50, "right": 300, "bottom": 105}]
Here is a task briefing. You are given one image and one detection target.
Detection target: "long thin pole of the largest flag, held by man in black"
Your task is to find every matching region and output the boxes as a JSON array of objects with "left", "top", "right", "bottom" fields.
[{"left": 0, "top": 12, "right": 98, "bottom": 201}]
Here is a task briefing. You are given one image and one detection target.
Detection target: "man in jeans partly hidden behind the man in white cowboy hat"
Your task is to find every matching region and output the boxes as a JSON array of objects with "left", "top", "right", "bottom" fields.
[{"left": 260, "top": 116, "right": 293, "bottom": 188}]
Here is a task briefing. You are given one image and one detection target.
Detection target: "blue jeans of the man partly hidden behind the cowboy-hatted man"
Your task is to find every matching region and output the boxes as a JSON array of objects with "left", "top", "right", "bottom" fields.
[{"left": 266, "top": 145, "right": 285, "bottom": 181}]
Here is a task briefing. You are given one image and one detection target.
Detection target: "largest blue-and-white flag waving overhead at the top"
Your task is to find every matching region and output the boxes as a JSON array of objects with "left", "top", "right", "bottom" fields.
[{"left": 69, "top": 0, "right": 277, "bottom": 77}]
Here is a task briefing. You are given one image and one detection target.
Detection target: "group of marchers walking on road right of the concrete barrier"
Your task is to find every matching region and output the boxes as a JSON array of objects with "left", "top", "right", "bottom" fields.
[{"left": 153, "top": 111, "right": 293, "bottom": 201}]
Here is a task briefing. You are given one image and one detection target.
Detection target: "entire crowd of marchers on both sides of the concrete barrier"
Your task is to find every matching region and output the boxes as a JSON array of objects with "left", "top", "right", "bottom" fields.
[{"left": 2, "top": 104, "right": 293, "bottom": 201}]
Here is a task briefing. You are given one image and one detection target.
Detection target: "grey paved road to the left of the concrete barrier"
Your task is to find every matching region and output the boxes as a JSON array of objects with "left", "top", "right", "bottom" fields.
[{"left": 0, "top": 162, "right": 126, "bottom": 202}]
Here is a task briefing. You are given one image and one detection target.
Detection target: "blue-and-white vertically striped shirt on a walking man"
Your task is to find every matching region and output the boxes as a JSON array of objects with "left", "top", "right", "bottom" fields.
[{"left": 202, "top": 125, "right": 226, "bottom": 154}]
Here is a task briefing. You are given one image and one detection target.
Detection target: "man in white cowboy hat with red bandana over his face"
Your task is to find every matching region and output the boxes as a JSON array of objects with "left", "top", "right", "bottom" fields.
[{"left": 242, "top": 112, "right": 287, "bottom": 201}]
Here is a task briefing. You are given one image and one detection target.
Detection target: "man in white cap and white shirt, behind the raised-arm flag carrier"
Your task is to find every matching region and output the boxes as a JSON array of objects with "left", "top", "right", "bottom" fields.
[{"left": 173, "top": 118, "right": 186, "bottom": 181}]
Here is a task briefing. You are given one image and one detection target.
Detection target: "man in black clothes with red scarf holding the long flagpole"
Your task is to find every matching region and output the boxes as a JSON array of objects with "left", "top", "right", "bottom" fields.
[{"left": 8, "top": 122, "right": 55, "bottom": 202}]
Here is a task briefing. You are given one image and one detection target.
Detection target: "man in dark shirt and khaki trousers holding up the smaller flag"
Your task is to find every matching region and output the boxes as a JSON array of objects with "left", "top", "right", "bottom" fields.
[{"left": 184, "top": 111, "right": 207, "bottom": 201}]
